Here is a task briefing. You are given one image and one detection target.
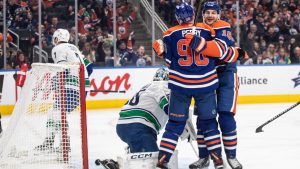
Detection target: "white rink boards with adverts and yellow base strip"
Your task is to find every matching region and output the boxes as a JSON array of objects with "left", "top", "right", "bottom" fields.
[{"left": 0, "top": 65, "right": 300, "bottom": 114}]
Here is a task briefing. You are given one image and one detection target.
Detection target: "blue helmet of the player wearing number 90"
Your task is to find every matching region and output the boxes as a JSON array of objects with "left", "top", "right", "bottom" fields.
[{"left": 175, "top": 2, "right": 195, "bottom": 25}]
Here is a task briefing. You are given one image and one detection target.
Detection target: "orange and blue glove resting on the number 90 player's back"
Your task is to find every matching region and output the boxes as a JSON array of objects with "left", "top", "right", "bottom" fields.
[{"left": 184, "top": 33, "right": 206, "bottom": 52}]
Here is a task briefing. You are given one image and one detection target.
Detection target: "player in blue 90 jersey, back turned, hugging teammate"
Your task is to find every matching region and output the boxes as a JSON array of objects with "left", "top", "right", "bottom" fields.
[{"left": 157, "top": 3, "right": 229, "bottom": 169}]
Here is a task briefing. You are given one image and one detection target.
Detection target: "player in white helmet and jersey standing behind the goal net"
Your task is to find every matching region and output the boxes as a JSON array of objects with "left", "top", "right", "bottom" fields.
[{"left": 35, "top": 29, "right": 93, "bottom": 151}]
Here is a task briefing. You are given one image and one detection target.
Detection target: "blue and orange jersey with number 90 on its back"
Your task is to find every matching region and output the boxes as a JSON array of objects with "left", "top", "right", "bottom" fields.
[{"left": 163, "top": 24, "right": 218, "bottom": 94}]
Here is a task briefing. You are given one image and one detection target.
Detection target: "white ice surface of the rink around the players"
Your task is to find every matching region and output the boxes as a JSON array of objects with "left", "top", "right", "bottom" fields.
[{"left": 2, "top": 103, "right": 300, "bottom": 169}]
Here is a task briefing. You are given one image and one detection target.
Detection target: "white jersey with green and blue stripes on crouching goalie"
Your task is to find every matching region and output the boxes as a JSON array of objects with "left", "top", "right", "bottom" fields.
[{"left": 118, "top": 81, "right": 170, "bottom": 133}]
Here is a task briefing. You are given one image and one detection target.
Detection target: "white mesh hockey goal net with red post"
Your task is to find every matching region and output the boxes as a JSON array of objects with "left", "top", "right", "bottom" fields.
[{"left": 0, "top": 63, "right": 88, "bottom": 169}]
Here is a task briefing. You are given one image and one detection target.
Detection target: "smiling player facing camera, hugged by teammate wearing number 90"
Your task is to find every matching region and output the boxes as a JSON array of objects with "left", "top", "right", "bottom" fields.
[{"left": 189, "top": 2, "right": 243, "bottom": 169}]
